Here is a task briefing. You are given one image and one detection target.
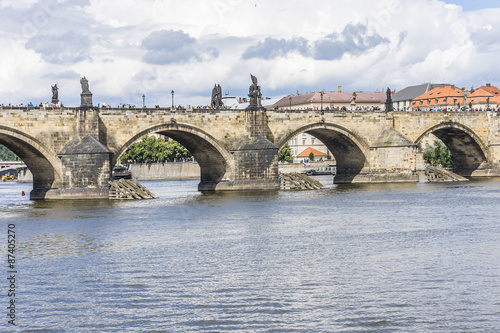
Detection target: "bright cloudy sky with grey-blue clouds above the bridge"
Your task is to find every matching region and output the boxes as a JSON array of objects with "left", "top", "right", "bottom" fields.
[{"left": 0, "top": 0, "right": 500, "bottom": 106}]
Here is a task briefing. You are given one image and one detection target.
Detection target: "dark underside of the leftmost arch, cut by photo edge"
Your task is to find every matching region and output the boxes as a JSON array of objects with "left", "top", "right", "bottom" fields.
[{"left": 0, "top": 133, "right": 57, "bottom": 196}]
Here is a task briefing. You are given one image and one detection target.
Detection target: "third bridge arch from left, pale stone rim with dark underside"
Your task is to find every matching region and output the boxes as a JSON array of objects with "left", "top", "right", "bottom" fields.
[{"left": 277, "top": 123, "right": 370, "bottom": 183}]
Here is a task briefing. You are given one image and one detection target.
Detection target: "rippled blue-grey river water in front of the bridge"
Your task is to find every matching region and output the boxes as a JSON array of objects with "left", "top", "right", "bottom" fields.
[{"left": 0, "top": 179, "right": 500, "bottom": 333}]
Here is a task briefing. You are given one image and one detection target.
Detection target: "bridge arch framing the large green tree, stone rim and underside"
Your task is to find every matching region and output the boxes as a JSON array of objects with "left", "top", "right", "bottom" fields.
[{"left": 112, "top": 123, "right": 232, "bottom": 190}]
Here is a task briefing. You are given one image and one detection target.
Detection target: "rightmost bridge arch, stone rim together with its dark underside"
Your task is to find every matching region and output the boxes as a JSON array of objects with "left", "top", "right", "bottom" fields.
[{"left": 415, "top": 122, "right": 488, "bottom": 176}]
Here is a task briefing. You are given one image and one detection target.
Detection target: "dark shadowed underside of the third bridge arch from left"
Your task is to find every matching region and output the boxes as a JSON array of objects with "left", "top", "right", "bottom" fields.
[{"left": 306, "top": 129, "right": 368, "bottom": 183}]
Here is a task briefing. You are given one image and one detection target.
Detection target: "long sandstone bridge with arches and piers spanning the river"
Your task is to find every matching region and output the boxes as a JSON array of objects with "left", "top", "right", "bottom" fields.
[{"left": 0, "top": 108, "right": 500, "bottom": 199}]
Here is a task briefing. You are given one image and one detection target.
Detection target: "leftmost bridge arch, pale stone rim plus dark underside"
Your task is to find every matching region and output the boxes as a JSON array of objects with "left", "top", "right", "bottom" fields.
[{"left": 0, "top": 126, "right": 62, "bottom": 199}]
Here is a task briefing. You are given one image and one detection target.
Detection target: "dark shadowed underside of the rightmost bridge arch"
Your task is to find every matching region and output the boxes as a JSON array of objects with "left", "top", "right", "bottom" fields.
[{"left": 432, "top": 128, "right": 488, "bottom": 176}]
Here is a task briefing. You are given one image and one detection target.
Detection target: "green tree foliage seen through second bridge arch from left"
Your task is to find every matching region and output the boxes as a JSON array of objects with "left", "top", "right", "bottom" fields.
[{"left": 120, "top": 137, "right": 191, "bottom": 163}]
